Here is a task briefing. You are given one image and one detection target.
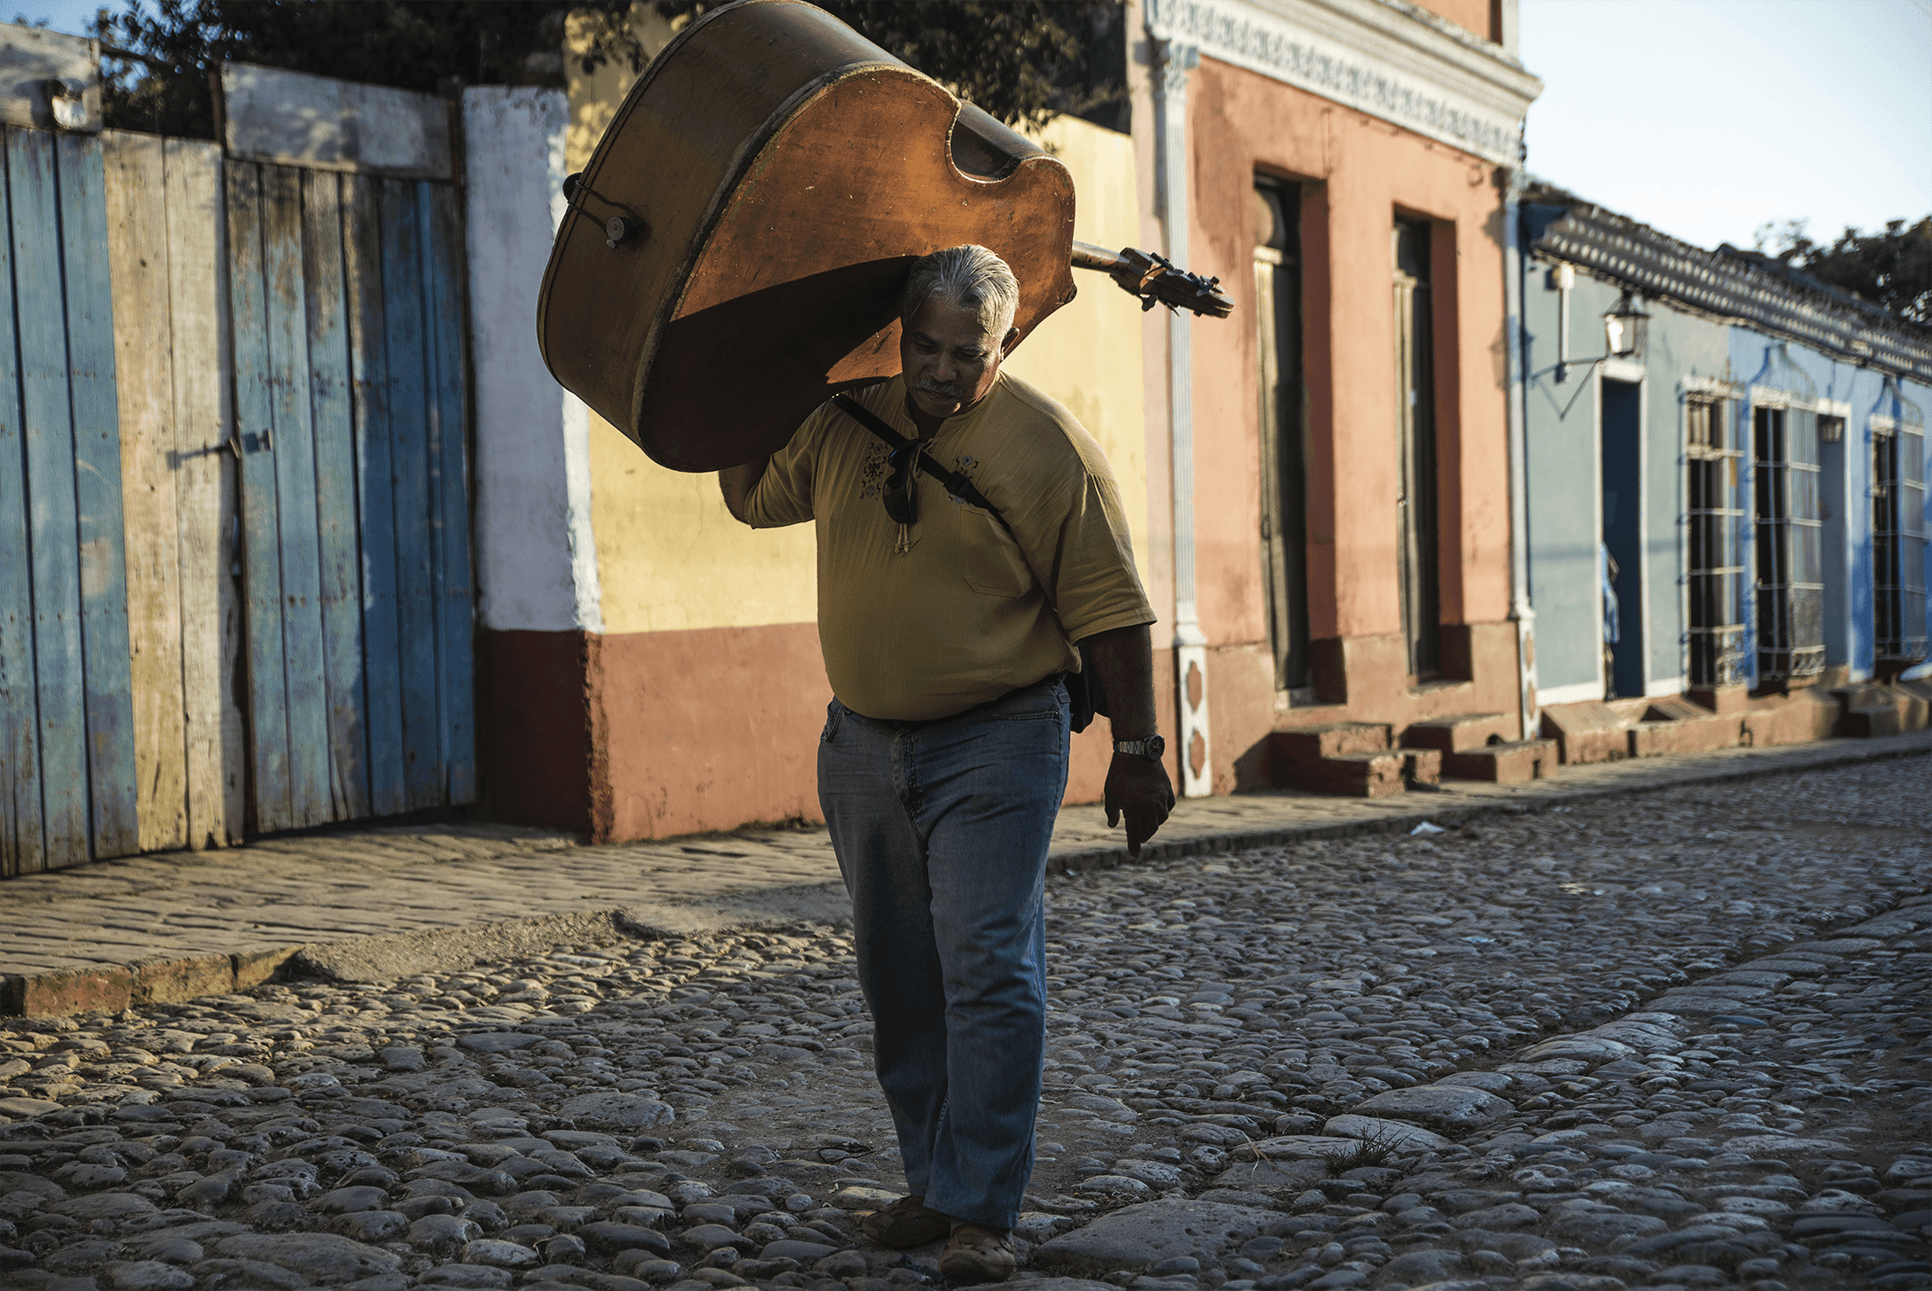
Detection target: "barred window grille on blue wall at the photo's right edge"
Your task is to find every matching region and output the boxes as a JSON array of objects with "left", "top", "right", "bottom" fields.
[{"left": 1872, "top": 383, "right": 1926, "bottom": 663}]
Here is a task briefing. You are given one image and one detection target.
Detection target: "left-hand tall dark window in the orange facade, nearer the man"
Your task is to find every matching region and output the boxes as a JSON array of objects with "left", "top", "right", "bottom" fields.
[{"left": 1254, "top": 180, "right": 1308, "bottom": 692}]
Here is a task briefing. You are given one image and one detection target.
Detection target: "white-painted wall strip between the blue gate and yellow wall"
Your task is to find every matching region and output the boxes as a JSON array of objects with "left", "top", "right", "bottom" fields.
[{"left": 464, "top": 85, "right": 603, "bottom": 632}]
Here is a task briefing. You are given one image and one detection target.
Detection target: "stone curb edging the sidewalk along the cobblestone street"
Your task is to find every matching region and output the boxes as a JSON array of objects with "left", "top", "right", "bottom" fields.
[{"left": 0, "top": 744, "right": 1932, "bottom": 1018}]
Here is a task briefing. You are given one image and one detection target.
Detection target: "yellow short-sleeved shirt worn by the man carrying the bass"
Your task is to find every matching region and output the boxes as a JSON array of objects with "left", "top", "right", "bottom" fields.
[{"left": 746, "top": 373, "right": 1153, "bottom": 721}]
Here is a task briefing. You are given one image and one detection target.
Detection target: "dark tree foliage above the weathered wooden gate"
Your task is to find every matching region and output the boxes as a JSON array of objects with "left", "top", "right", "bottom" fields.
[{"left": 93, "top": 0, "right": 647, "bottom": 137}]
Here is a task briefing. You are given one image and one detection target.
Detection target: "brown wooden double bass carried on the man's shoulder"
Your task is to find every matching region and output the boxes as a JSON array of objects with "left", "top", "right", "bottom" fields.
[{"left": 537, "top": 0, "right": 1233, "bottom": 472}]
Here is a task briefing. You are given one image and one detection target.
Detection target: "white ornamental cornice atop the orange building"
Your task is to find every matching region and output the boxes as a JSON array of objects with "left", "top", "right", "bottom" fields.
[{"left": 1146, "top": 0, "right": 1542, "bottom": 166}]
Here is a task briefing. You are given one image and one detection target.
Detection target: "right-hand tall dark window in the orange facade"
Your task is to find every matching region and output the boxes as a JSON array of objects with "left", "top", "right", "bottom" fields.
[{"left": 1393, "top": 220, "right": 1441, "bottom": 680}]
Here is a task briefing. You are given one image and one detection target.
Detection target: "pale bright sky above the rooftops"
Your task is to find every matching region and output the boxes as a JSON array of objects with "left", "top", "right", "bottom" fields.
[{"left": 15, "top": 0, "right": 1932, "bottom": 257}]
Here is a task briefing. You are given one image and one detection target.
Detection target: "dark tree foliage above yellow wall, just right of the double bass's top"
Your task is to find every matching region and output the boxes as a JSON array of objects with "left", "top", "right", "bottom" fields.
[{"left": 657, "top": 0, "right": 1126, "bottom": 129}]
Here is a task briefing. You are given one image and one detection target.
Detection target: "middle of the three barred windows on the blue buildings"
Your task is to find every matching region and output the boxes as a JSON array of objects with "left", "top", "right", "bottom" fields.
[{"left": 1752, "top": 406, "right": 1824, "bottom": 684}]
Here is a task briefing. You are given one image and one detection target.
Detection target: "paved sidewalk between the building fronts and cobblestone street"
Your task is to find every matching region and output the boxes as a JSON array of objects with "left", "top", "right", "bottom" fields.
[{"left": 0, "top": 731, "right": 1932, "bottom": 1017}]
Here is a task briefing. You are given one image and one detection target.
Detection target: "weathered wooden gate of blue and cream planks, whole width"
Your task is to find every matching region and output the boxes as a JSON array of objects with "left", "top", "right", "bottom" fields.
[{"left": 0, "top": 50, "right": 477, "bottom": 877}]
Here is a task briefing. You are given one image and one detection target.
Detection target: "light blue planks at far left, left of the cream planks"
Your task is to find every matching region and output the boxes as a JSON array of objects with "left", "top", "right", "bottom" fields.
[{"left": 0, "top": 128, "right": 139, "bottom": 875}]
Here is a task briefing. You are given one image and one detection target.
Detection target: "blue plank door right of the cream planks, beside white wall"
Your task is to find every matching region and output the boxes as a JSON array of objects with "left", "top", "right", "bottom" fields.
[{"left": 226, "top": 162, "right": 475, "bottom": 831}]
